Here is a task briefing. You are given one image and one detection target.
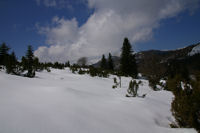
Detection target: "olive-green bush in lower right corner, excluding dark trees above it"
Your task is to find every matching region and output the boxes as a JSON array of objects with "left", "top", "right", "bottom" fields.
[{"left": 167, "top": 74, "right": 200, "bottom": 132}]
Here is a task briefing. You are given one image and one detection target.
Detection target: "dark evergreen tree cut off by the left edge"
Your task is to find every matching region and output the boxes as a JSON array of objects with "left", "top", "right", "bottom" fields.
[{"left": 0, "top": 43, "right": 10, "bottom": 66}]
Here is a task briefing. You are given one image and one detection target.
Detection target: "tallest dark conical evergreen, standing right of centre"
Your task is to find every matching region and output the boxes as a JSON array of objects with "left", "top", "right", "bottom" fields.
[{"left": 120, "top": 38, "right": 138, "bottom": 77}]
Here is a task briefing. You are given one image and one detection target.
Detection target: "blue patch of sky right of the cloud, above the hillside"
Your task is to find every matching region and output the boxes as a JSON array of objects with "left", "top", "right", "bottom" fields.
[{"left": 137, "top": 9, "right": 200, "bottom": 51}]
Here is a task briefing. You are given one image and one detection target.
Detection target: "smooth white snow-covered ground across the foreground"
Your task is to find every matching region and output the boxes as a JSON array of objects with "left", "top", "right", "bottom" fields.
[{"left": 0, "top": 69, "right": 196, "bottom": 133}]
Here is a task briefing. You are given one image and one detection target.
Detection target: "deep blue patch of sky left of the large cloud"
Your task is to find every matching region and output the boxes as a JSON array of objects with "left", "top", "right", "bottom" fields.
[{"left": 0, "top": 0, "right": 92, "bottom": 57}]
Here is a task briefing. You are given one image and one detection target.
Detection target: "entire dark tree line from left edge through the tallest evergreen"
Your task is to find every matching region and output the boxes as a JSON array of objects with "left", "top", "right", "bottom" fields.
[{"left": 0, "top": 38, "right": 137, "bottom": 78}]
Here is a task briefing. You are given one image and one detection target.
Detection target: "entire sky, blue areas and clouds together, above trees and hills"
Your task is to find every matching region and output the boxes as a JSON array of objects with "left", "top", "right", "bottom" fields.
[{"left": 0, "top": 0, "right": 200, "bottom": 62}]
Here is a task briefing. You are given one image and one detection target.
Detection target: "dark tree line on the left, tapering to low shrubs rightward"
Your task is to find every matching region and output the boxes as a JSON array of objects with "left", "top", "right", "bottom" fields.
[{"left": 0, "top": 43, "right": 70, "bottom": 78}]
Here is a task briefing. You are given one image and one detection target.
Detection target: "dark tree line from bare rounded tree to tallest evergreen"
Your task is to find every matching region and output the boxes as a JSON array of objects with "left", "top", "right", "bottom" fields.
[{"left": 70, "top": 38, "right": 138, "bottom": 78}]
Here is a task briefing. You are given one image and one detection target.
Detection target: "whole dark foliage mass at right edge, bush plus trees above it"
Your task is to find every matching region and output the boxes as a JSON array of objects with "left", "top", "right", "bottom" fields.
[{"left": 166, "top": 54, "right": 200, "bottom": 132}]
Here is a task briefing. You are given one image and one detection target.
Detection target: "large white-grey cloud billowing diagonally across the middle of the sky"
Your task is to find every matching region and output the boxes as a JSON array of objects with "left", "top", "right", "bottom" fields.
[{"left": 35, "top": 0, "right": 198, "bottom": 62}]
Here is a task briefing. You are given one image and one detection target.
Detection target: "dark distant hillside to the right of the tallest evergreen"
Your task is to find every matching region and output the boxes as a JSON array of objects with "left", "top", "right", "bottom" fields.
[{"left": 136, "top": 43, "right": 200, "bottom": 76}]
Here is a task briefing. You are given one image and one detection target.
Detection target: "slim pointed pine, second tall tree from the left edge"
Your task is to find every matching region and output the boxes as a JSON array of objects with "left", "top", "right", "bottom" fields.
[{"left": 26, "top": 45, "right": 35, "bottom": 78}]
